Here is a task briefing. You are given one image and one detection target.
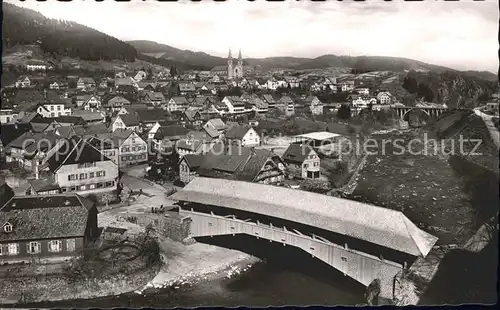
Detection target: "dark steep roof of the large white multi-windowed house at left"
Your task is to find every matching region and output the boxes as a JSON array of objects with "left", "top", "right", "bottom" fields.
[{"left": 47, "top": 137, "right": 110, "bottom": 172}]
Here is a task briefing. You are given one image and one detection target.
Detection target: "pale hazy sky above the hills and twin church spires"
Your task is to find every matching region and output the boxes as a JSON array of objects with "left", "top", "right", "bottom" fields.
[{"left": 8, "top": 0, "right": 499, "bottom": 73}]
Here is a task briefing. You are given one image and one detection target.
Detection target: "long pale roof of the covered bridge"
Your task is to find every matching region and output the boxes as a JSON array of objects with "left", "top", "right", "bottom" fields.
[{"left": 170, "top": 177, "right": 438, "bottom": 256}]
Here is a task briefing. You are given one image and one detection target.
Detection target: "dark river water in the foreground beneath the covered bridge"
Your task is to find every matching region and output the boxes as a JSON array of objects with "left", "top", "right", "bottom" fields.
[{"left": 19, "top": 236, "right": 365, "bottom": 308}]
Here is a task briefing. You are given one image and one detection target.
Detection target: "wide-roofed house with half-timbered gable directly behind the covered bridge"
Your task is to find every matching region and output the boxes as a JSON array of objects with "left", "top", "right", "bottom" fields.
[{"left": 191, "top": 143, "right": 285, "bottom": 185}]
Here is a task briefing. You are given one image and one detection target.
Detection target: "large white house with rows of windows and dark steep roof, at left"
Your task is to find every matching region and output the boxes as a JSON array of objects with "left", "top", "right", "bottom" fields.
[{"left": 47, "top": 137, "right": 118, "bottom": 194}]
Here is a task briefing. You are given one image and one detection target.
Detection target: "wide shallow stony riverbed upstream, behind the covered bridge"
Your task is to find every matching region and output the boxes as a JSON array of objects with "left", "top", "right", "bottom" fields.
[{"left": 351, "top": 132, "right": 476, "bottom": 244}]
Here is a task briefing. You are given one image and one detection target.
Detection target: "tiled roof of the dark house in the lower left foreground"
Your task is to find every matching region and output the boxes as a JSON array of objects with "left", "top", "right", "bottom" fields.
[{"left": 0, "top": 194, "right": 94, "bottom": 242}]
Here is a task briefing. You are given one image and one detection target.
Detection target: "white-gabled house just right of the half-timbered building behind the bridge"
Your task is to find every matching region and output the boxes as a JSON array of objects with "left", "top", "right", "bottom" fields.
[{"left": 283, "top": 143, "right": 320, "bottom": 179}]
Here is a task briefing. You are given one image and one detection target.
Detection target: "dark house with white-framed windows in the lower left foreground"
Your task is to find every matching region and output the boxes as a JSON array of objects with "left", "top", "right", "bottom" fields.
[{"left": 0, "top": 193, "right": 98, "bottom": 264}]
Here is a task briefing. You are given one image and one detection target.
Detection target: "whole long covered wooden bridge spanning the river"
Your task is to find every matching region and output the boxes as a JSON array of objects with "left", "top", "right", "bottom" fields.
[{"left": 171, "top": 177, "right": 437, "bottom": 299}]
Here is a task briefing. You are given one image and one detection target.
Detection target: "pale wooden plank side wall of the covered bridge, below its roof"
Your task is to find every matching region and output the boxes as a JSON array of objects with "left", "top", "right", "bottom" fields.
[{"left": 179, "top": 209, "right": 403, "bottom": 298}]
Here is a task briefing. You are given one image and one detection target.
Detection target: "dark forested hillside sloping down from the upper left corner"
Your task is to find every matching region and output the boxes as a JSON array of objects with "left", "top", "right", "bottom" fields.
[{"left": 2, "top": 3, "right": 137, "bottom": 61}]
